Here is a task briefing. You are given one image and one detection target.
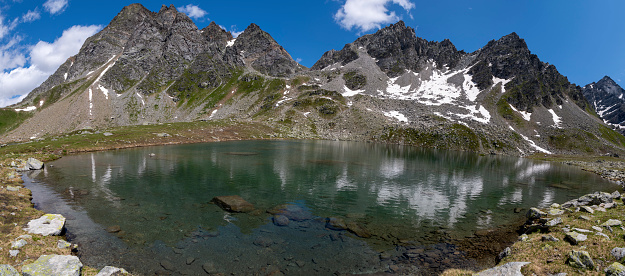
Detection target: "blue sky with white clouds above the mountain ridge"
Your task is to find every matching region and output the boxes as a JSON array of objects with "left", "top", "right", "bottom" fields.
[{"left": 0, "top": 0, "right": 625, "bottom": 106}]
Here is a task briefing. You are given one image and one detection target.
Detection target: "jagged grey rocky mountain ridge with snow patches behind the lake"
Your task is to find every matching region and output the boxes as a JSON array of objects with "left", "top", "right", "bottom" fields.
[{"left": 3, "top": 4, "right": 625, "bottom": 155}]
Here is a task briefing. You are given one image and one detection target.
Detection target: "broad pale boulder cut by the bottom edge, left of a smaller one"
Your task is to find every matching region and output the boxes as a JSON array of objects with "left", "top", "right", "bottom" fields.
[{"left": 22, "top": 255, "right": 82, "bottom": 276}]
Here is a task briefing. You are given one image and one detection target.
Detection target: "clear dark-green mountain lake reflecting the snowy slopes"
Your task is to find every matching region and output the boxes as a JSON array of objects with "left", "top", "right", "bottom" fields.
[{"left": 24, "top": 141, "right": 618, "bottom": 275}]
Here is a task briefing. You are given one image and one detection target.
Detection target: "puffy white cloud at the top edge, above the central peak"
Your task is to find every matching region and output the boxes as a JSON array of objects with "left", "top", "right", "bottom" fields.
[{"left": 334, "top": 0, "right": 415, "bottom": 32}]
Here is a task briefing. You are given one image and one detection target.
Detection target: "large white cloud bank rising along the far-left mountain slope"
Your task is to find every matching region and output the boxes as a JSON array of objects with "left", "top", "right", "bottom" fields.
[{"left": 0, "top": 26, "right": 102, "bottom": 106}]
